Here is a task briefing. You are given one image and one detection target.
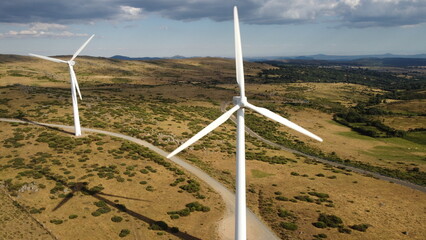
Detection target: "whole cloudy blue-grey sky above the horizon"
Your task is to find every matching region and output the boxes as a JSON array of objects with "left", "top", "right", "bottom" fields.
[{"left": 0, "top": 0, "right": 426, "bottom": 57}]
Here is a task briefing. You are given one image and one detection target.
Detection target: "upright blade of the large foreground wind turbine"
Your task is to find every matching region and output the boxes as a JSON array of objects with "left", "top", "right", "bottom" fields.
[{"left": 234, "top": 6, "right": 245, "bottom": 97}]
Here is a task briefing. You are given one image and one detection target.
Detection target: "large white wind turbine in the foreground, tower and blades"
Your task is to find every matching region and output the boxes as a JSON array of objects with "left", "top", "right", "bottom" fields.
[{"left": 167, "top": 6, "right": 322, "bottom": 240}]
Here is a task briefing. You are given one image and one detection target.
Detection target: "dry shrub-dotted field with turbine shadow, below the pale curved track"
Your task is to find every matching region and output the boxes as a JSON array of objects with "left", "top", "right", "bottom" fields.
[{"left": 0, "top": 123, "right": 223, "bottom": 239}]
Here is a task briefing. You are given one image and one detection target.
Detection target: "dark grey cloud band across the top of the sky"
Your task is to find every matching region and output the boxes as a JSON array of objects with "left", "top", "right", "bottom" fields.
[{"left": 0, "top": 0, "right": 426, "bottom": 28}]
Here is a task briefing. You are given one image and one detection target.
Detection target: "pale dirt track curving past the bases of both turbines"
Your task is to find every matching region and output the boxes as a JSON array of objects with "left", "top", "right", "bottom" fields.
[{"left": 0, "top": 118, "right": 280, "bottom": 240}]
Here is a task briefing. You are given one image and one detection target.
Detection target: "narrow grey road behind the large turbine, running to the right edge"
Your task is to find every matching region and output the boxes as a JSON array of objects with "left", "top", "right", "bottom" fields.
[{"left": 221, "top": 103, "right": 426, "bottom": 193}]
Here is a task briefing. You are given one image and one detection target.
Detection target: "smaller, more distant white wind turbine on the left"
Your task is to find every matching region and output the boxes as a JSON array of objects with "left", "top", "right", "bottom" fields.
[{"left": 29, "top": 34, "right": 95, "bottom": 136}]
